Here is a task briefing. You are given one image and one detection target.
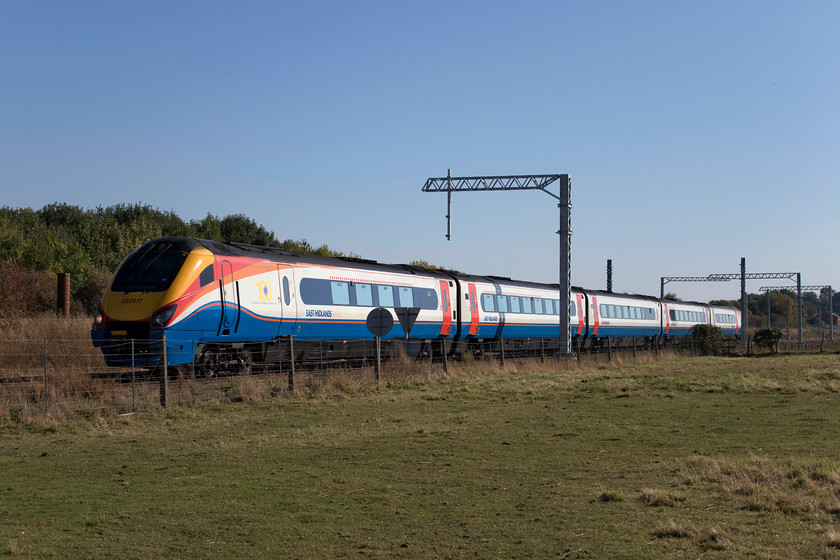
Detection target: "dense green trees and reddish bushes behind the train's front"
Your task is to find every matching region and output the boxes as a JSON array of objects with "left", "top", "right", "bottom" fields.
[{"left": 0, "top": 203, "right": 345, "bottom": 317}]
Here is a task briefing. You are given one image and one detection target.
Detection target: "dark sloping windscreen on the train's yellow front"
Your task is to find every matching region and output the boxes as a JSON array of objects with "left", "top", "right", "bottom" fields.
[{"left": 111, "top": 241, "right": 188, "bottom": 293}]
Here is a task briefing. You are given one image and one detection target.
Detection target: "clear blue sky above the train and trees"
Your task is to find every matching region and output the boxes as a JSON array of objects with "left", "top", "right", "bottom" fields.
[{"left": 0, "top": 0, "right": 840, "bottom": 299}]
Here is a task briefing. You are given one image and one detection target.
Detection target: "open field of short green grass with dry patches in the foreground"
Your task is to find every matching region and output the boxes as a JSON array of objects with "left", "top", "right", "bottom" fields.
[{"left": 0, "top": 354, "right": 840, "bottom": 559}]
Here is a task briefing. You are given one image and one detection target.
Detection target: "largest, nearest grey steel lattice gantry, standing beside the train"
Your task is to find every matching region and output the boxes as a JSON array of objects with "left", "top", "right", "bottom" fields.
[{"left": 423, "top": 170, "right": 572, "bottom": 356}]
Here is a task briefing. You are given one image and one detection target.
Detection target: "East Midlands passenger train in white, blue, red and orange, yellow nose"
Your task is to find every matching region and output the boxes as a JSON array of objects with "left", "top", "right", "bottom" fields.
[{"left": 91, "top": 237, "right": 741, "bottom": 376}]
